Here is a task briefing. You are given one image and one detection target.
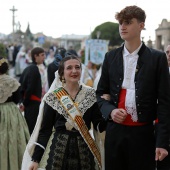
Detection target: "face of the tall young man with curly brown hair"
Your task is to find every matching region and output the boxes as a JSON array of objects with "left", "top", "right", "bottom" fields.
[{"left": 119, "top": 18, "right": 145, "bottom": 41}]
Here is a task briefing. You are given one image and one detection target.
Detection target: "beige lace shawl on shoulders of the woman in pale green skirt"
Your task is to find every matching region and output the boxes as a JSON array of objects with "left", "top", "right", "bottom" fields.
[{"left": 0, "top": 74, "right": 20, "bottom": 103}]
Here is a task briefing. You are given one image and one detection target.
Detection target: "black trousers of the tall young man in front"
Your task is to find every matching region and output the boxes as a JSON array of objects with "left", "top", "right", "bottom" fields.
[{"left": 105, "top": 122, "right": 156, "bottom": 170}]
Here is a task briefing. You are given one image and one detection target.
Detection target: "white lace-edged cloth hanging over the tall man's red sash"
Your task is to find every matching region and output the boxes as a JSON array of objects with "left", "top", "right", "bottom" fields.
[{"left": 125, "top": 89, "right": 138, "bottom": 122}]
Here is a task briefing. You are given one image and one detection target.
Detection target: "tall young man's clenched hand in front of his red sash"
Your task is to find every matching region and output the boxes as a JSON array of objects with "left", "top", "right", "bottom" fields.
[{"left": 110, "top": 109, "right": 127, "bottom": 123}]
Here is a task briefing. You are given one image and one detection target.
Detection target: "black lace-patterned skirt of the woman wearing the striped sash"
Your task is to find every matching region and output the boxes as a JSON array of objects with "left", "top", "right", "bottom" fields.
[{"left": 46, "top": 130, "right": 95, "bottom": 170}]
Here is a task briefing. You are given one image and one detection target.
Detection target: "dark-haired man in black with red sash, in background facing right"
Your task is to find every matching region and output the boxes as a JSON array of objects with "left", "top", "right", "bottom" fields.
[{"left": 19, "top": 47, "right": 45, "bottom": 134}]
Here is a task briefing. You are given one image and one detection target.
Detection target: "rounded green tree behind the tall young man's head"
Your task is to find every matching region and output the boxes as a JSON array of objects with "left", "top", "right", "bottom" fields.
[{"left": 91, "top": 22, "right": 123, "bottom": 46}]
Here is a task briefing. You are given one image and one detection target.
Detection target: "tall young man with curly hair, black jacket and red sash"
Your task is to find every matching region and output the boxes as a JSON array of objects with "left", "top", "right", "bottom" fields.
[{"left": 97, "top": 6, "right": 170, "bottom": 170}]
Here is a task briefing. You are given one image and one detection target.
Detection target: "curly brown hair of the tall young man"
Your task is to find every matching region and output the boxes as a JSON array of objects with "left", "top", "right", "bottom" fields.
[{"left": 115, "top": 5, "right": 146, "bottom": 23}]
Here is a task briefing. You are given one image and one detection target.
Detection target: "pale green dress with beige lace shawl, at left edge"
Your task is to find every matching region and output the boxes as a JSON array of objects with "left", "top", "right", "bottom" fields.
[{"left": 0, "top": 74, "right": 30, "bottom": 170}]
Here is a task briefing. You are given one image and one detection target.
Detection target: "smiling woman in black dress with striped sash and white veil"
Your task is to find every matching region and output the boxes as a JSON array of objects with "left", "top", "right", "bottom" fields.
[{"left": 22, "top": 55, "right": 106, "bottom": 170}]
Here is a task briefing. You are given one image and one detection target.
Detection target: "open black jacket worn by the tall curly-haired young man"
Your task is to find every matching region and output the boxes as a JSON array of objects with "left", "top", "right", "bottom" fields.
[{"left": 96, "top": 44, "right": 170, "bottom": 148}]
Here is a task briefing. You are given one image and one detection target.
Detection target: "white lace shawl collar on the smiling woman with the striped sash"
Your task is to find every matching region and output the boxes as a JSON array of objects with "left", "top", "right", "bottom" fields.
[{"left": 44, "top": 85, "right": 96, "bottom": 129}]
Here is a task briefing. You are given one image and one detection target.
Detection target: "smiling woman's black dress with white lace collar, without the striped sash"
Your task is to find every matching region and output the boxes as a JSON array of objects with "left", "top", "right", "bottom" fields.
[{"left": 32, "top": 87, "right": 106, "bottom": 170}]
